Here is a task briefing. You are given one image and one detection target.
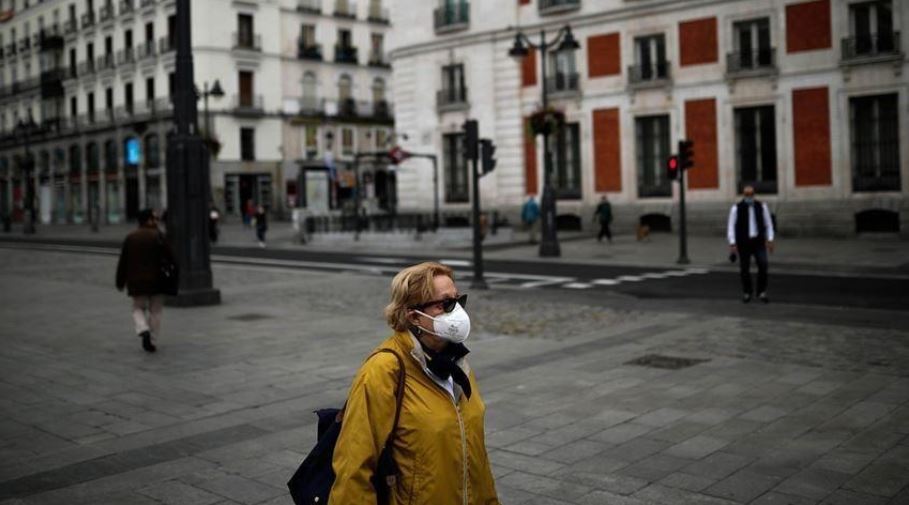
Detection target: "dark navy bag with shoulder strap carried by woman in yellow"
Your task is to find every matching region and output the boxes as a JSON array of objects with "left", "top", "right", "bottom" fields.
[{"left": 287, "top": 349, "right": 404, "bottom": 505}]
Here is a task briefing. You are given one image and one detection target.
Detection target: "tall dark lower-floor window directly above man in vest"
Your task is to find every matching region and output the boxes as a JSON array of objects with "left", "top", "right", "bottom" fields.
[{"left": 734, "top": 105, "right": 777, "bottom": 194}]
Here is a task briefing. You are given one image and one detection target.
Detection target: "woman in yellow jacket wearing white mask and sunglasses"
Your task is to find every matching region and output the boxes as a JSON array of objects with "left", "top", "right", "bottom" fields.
[{"left": 329, "top": 263, "right": 499, "bottom": 505}]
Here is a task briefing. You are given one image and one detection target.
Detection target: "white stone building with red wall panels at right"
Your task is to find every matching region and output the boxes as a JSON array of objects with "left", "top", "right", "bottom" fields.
[{"left": 390, "top": 0, "right": 909, "bottom": 235}]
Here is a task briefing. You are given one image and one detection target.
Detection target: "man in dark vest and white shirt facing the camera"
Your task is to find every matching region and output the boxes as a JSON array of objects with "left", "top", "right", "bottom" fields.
[{"left": 726, "top": 186, "right": 774, "bottom": 303}]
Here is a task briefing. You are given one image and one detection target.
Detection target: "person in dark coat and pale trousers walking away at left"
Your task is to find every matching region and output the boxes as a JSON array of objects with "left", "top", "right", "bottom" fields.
[{"left": 117, "top": 209, "right": 176, "bottom": 352}]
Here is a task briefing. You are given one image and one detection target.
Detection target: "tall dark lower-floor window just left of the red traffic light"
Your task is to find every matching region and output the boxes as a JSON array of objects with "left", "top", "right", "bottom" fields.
[{"left": 635, "top": 115, "right": 672, "bottom": 198}]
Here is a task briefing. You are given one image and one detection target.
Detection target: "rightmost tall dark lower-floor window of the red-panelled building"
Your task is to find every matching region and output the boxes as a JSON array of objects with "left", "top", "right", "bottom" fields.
[{"left": 849, "top": 93, "right": 900, "bottom": 191}]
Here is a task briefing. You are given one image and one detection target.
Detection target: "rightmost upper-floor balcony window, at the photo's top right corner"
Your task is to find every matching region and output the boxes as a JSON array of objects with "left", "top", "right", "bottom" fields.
[{"left": 843, "top": 0, "right": 898, "bottom": 57}]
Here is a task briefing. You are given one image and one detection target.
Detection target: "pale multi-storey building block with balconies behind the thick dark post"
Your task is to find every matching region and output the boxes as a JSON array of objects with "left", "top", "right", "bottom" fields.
[{"left": 0, "top": 0, "right": 391, "bottom": 223}]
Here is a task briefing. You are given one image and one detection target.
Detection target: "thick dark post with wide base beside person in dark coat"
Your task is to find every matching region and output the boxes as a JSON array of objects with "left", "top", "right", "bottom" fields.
[{"left": 167, "top": 0, "right": 221, "bottom": 306}]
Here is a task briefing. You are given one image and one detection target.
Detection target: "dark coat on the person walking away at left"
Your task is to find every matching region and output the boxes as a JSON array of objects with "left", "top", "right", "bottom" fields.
[{"left": 117, "top": 227, "right": 176, "bottom": 296}]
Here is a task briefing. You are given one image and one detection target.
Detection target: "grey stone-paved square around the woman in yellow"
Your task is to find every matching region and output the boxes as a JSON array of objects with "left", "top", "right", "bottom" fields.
[{"left": 0, "top": 250, "right": 909, "bottom": 505}]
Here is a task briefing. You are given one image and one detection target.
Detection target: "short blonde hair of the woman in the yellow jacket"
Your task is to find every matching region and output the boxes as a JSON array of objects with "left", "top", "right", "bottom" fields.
[{"left": 385, "top": 261, "right": 454, "bottom": 331}]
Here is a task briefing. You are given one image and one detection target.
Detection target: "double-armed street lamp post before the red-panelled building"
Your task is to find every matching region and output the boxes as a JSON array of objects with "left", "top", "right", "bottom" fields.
[{"left": 508, "top": 25, "right": 580, "bottom": 256}]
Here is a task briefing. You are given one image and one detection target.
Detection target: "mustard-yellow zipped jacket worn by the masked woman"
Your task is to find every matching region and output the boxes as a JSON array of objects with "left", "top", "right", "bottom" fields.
[{"left": 328, "top": 333, "right": 499, "bottom": 505}]
